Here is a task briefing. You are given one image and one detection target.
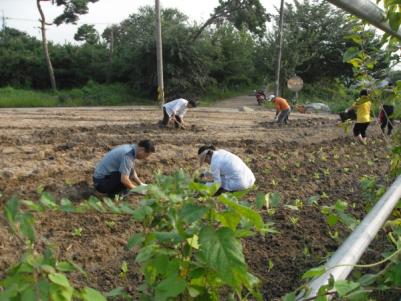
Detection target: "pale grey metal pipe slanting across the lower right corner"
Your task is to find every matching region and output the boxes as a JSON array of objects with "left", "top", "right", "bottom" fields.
[{"left": 297, "top": 176, "right": 401, "bottom": 301}]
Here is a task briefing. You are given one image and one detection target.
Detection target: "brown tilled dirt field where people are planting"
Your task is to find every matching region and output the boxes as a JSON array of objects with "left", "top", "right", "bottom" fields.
[{"left": 0, "top": 97, "right": 388, "bottom": 300}]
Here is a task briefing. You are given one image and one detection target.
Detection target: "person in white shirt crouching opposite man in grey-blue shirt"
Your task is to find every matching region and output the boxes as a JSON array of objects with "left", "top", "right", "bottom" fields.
[{"left": 198, "top": 145, "right": 255, "bottom": 195}]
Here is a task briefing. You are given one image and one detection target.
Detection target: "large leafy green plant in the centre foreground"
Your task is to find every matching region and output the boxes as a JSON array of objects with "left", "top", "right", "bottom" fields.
[{"left": 128, "top": 172, "right": 272, "bottom": 300}]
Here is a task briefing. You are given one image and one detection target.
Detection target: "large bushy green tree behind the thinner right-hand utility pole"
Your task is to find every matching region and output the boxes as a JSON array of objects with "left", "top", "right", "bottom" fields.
[{"left": 259, "top": 0, "right": 353, "bottom": 89}]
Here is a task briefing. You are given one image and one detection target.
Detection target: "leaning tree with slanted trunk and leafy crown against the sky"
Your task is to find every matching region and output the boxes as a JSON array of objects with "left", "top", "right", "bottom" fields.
[{"left": 192, "top": 0, "right": 270, "bottom": 41}]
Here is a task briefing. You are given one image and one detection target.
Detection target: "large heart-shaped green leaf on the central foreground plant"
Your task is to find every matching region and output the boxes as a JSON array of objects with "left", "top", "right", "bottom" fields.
[{"left": 199, "top": 226, "right": 246, "bottom": 288}]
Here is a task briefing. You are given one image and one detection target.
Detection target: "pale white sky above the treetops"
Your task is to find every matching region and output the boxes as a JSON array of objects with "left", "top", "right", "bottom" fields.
[{"left": 0, "top": 0, "right": 288, "bottom": 44}]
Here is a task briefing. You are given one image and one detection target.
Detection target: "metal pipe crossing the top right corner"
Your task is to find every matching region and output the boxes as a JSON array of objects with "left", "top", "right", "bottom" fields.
[{"left": 327, "top": 0, "right": 401, "bottom": 39}]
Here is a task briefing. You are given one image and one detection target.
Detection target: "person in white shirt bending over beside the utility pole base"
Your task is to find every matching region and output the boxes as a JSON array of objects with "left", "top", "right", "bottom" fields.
[{"left": 160, "top": 98, "right": 197, "bottom": 128}]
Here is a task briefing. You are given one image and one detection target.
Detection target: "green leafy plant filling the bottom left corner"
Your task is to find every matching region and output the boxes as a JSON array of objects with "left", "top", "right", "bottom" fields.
[{"left": 0, "top": 199, "right": 109, "bottom": 301}]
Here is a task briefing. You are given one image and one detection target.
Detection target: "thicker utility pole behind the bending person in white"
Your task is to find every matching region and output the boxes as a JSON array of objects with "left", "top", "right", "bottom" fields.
[{"left": 155, "top": 0, "right": 164, "bottom": 105}]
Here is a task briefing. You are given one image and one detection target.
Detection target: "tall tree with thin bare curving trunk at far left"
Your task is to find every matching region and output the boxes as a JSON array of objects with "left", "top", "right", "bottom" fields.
[{"left": 36, "top": 0, "right": 98, "bottom": 91}]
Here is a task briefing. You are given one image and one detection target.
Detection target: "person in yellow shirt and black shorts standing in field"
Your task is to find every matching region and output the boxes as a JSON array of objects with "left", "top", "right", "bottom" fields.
[{"left": 349, "top": 89, "right": 372, "bottom": 145}]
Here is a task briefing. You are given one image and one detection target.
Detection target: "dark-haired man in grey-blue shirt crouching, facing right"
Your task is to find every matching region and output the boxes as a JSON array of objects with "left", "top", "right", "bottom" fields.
[{"left": 93, "top": 140, "right": 155, "bottom": 197}]
